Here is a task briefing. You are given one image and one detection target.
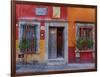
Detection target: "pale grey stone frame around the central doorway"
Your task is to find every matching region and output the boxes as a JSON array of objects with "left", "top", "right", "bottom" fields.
[{"left": 45, "top": 22, "right": 68, "bottom": 63}]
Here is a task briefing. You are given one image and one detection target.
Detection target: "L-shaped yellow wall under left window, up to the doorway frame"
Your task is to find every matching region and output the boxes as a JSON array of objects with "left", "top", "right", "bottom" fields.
[{"left": 21, "top": 40, "right": 45, "bottom": 63}]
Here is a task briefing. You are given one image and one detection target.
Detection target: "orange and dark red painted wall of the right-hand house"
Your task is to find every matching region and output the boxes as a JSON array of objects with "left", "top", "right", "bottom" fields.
[{"left": 67, "top": 7, "right": 95, "bottom": 62}]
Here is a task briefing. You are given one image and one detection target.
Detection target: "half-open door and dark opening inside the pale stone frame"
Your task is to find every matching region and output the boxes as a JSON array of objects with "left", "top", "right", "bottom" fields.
[{"left": 48, "top": 27, "right": 64, "bottom": 59}]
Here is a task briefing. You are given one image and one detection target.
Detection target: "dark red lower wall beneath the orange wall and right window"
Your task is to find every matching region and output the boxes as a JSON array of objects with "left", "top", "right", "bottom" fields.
[{"left": 68, "top": 47, "right": 94, "bottom": 63}]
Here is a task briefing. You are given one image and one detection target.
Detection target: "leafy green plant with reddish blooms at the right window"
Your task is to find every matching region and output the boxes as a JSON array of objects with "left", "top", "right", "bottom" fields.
[{"left": 76, "top": 38, "right": 93, "bottom": 50}]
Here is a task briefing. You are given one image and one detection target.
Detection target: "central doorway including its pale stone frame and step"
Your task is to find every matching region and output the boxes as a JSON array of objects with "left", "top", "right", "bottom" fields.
[{"left": 45, "top": 22, "right": 68, "bottom": 65}]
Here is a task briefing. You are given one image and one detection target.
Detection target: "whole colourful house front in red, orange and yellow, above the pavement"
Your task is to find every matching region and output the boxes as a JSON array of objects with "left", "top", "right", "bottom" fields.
[{"left": 16, "top": 4, "right": 95, "bottom": 64}]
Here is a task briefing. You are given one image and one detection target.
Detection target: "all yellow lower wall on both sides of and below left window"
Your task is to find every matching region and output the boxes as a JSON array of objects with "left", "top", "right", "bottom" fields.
[{"left": 16, "top": 40, "right": 45, "bottom": 63}]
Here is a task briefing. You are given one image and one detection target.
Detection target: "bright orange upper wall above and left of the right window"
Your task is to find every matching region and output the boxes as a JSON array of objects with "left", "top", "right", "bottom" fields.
[{"left": 67, "top": 7, "right": 95, "bottom": 47}]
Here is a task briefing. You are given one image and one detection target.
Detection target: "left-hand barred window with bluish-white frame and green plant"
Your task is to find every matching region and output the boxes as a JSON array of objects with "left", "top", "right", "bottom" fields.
[{"left": 19, "top": 24, "right": 40, "bottom": 53}]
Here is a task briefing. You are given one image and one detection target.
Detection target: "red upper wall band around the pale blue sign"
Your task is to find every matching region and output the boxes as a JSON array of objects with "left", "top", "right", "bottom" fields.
[{"left": 16, "top": 4, "right": 67, "bottom": 19}]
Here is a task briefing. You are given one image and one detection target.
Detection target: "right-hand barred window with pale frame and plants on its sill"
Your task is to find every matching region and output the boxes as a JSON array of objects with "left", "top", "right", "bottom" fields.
[{"left": 76, "top": 23, "right": 95, "bottom": 50}]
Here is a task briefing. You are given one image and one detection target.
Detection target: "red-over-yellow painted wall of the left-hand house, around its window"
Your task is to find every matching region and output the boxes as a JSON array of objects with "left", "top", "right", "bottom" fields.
[{"left": 16, "top": 5, "right": 67, "bottom": 63}]
